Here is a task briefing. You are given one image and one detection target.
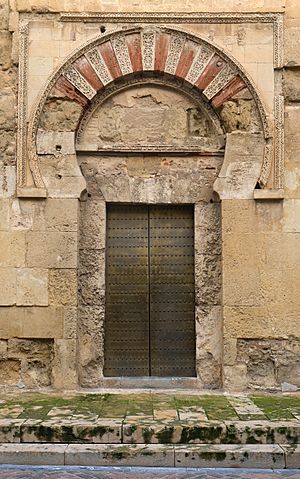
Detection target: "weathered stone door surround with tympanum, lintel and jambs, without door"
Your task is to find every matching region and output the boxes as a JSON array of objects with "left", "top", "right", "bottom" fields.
[{"left": 77, "top": 81, "right": 224, "bottom": 387}]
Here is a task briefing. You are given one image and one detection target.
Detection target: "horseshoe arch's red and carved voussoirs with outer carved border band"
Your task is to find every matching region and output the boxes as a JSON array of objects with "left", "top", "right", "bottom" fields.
[{"left": 18, "top": 26, "right": 272, "bottom": 195}]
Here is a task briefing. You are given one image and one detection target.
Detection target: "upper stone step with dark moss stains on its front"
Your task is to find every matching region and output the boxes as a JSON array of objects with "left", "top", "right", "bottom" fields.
[{"left": 0, "top": 416, "right": 300, "bottom": 445}]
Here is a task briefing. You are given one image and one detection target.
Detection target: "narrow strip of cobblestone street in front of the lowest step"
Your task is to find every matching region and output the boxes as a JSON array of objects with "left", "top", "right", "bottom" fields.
[{"left": 0, "top": 466, "right": 300, "bottom": 479}]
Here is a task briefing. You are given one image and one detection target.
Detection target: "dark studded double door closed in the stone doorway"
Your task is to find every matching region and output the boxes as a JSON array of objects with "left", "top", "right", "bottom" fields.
[{"left": 104, "top": 203, "right": 195, "bottom": 377}]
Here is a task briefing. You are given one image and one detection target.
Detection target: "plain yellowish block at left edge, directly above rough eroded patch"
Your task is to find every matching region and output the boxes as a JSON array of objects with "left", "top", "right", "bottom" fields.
[{"left": 0, "top": 306, "right": 63, "bottom": 339}]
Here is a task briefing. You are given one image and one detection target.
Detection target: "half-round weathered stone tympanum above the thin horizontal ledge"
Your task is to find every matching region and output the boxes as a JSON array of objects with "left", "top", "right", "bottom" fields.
[{"left": 79, "top": 85, "right": 220, "bottom": 149}]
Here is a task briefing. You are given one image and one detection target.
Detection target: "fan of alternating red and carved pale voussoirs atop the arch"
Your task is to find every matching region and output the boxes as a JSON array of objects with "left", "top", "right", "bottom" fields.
[{"left": 55, "top": 30, "right": 247, "bottom": 108}]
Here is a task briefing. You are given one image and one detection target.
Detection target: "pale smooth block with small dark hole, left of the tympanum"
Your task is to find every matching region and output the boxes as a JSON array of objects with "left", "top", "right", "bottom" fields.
[{"left": 36, "top": 129, "right": 75, "bottom": 155}]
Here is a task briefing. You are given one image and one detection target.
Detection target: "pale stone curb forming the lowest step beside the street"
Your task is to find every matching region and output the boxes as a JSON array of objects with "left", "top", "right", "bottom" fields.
[{"left": 0, "top": 444, "right": 300, "bottom": 469}]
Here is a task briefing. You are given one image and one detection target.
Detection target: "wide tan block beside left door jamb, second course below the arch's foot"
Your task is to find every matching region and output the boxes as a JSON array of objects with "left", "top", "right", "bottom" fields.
[{"left": 26, "top": 231, "right": 77, "bottom": 269}]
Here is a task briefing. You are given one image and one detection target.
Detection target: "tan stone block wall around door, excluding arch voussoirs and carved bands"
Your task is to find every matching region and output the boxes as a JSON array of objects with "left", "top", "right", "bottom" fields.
[{"left": 0, "top": 0, "right": 300, "bottom": 391}]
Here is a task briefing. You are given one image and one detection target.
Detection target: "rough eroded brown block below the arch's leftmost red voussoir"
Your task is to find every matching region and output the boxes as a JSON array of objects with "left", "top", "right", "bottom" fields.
[{"left": 40, "top": 98, "right": 82, "bottom": 131}]
